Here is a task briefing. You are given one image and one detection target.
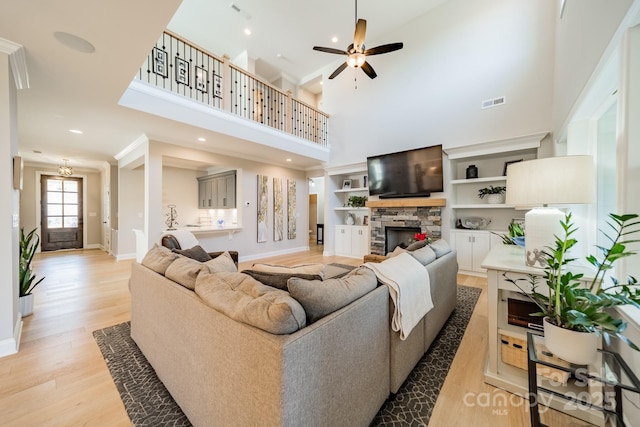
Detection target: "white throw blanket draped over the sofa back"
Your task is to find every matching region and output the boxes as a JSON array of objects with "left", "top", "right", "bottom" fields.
[{"left": 364, "top": 253, "right": 433, "bottom": 340}]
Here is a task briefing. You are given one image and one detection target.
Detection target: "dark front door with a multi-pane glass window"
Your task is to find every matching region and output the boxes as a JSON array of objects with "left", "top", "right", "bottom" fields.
[{"left": 40, "top": 175, "right": 83, "bottom": 251}]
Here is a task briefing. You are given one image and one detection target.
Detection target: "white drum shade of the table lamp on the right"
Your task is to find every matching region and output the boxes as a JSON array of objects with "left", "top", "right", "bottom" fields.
[{"left": 505, "top": 156, "right": 596, "bottom": 207}]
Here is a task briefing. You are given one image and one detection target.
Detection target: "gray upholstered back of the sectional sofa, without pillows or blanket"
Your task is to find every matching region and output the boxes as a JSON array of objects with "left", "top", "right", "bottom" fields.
[{"left": 129, "top": 246, "right": 458, "bottom": 426}]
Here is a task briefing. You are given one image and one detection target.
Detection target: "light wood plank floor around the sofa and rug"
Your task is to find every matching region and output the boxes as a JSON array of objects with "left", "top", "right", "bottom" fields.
[{"left": 0, "top": 246, "right": 582, "bottom": 427}]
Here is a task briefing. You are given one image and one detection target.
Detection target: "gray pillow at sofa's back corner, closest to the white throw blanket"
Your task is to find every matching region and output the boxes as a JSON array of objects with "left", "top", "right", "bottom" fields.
[{"left": 288, "top": 267, "right": 378, "bottom": 323}]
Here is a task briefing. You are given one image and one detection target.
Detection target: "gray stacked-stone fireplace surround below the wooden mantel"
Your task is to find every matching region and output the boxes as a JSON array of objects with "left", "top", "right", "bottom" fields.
[{"left": 370, "top": 206, "right": 442, "bottom": 255}]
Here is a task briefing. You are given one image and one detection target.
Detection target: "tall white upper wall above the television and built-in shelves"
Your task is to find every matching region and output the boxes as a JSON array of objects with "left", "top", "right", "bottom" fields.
[{"left": 323, "top": 0, "right": 556, "bottom": 167}]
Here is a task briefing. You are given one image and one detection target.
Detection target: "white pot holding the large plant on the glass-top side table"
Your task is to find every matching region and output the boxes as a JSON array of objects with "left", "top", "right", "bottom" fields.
[{"left": 543, "top": 317, "right": 598, "bottom": 365}]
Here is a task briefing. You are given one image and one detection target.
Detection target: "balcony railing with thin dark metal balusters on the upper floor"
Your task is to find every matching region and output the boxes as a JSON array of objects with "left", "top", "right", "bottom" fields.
[{"left": 136, "top": 31, "right": 329, "bottom": 146}]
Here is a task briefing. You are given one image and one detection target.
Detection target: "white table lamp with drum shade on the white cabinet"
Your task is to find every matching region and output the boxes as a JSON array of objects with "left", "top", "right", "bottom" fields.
[{"left": 505, "top": 156, "right": 596, "bottom": 268}]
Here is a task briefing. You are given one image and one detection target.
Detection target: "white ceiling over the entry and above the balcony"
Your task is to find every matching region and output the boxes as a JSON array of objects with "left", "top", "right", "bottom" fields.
[{"left": 0, "top": 0, "right": 445, "bottom": 171}]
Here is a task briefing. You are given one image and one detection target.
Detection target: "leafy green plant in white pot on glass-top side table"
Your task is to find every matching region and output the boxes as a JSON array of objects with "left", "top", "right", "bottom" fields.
[{"left": 504, "top": 214, "right": 640, "bottom": 365}]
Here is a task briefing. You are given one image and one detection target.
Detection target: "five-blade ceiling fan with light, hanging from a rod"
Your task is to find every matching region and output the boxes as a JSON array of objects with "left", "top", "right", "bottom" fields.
[{"left": 313, "top": 0, "right": 403, "bottom": 79}]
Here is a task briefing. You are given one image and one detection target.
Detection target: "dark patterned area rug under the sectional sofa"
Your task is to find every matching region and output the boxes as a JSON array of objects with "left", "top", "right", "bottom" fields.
[{"left": 93, "top": 285, "right": 481, "bottom": 427}]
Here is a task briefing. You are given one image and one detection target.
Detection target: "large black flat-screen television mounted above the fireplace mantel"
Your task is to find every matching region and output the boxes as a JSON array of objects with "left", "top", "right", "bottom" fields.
[{"left": 367, "top": 145, "right": 443, "bottom": 199}]
